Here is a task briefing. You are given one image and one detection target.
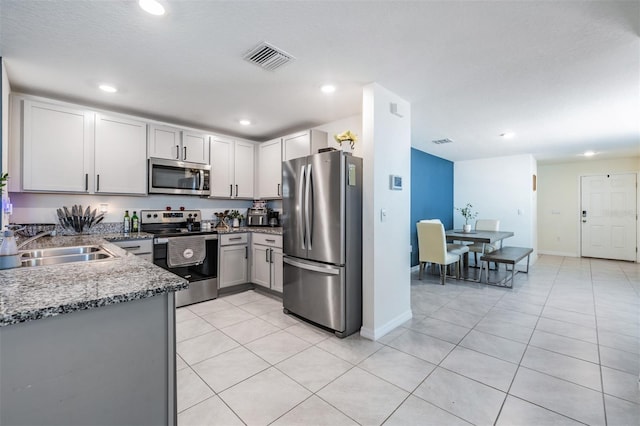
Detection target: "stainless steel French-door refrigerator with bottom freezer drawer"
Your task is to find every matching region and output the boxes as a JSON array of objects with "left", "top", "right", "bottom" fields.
[{"left": 282, "top": 151, "right": 362, "bottom": 337}]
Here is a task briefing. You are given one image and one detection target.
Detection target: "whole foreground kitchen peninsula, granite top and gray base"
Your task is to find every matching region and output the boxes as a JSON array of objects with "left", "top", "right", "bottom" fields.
[{"left": 0, "top": 235, "right": 181, "bottom": 426}]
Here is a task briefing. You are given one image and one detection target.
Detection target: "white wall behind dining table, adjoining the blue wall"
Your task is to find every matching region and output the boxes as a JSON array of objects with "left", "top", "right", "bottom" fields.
[{"left": 453, "top": 155, "right": 537, "bottom": 261}]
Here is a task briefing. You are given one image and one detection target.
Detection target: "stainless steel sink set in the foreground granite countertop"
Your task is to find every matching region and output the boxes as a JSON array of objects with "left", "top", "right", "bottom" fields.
[{"left": 20, "top": 246, "right": 116, "bottom": 266}]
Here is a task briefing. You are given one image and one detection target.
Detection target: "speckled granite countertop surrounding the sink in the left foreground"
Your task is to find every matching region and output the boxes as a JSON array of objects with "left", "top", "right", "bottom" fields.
[{"left": 0, "top": 234, "right": 188, "bottom": 327}]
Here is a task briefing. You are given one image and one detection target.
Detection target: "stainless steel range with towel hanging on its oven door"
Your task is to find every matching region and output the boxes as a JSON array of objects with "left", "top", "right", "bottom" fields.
[{"left": 140, "top": 210, "right": 218, "bottom": 307}]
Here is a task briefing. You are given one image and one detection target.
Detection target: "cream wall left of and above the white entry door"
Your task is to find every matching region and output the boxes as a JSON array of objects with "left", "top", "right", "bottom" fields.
[{"left": 538, "top": 157, "right": 640, "bottom": 257}]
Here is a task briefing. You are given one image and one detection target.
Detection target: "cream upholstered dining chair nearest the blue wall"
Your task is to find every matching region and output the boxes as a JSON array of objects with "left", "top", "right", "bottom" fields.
[{"left": 416, "top": 220, "right": 461, "bottom": 285}]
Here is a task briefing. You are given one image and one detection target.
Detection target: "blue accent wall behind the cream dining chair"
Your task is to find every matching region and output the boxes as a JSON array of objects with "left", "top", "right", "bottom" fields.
[{"left": 410, "top": 148, "right": 453, "bottom": 266}]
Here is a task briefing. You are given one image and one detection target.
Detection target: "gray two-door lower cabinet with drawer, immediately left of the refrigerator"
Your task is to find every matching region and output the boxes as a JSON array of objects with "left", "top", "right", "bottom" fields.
[{"left": 251, "top": 233, "right": 283, "bottom": 293}]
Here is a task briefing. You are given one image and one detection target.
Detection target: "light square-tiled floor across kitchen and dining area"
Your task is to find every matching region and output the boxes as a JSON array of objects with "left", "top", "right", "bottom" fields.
[{"left": 177, "top": 256, "right": 640, "bottom": 426}]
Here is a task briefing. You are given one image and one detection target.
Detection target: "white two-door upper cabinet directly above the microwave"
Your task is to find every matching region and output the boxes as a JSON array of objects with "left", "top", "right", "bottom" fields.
[{"left": 149, "top": 124, "right": 209, "bottom": 164}]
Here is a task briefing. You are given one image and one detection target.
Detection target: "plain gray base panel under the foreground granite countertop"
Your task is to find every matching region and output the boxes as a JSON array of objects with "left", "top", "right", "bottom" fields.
[{"left": 0, "top": 293, "right": 177, "bottom": 425}]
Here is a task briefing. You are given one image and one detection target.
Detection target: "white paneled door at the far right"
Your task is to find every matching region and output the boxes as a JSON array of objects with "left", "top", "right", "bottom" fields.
[{"left": 580, "top": 173, "right": 637, "bottom": 261}]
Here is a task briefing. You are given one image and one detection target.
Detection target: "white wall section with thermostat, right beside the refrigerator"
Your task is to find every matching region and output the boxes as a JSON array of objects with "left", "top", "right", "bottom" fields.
[{"left": 360, "top": 84, "right": 412, "bottom": 340}]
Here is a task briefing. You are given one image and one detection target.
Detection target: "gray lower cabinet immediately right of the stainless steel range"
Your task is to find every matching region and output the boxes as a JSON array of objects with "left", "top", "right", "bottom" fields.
[{"left": 218, "top": 233, "right": 249, "bottom": 288}]
